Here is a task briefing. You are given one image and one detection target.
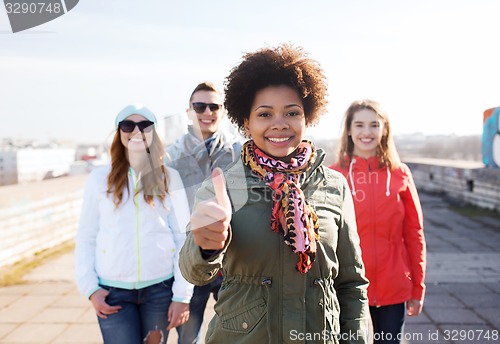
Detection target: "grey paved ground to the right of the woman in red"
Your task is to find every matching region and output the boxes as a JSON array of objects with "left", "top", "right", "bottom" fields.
[{"left": 406, "top": 194, "right": 500, "bottom": 344}]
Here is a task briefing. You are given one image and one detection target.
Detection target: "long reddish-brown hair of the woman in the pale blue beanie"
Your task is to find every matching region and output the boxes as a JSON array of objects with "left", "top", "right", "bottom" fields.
[{"left": 107, "top": 128, "right": 169, "bottom": 208}]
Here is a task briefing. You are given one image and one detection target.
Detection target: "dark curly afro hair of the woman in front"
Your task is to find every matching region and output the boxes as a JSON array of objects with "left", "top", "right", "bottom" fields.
[{"left": 224, "top": 43, "right": 327, "bottom": 133}]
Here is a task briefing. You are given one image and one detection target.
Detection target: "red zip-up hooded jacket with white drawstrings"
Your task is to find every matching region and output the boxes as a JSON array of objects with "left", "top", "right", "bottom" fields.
[{"left": 330, "top": 156, "right": 426, "bottom": 306}]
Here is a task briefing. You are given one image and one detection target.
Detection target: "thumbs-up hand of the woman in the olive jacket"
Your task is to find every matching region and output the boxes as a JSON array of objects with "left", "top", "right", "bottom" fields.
[{"left": 191, "top": 168, "right": 231, "bottom": 250}]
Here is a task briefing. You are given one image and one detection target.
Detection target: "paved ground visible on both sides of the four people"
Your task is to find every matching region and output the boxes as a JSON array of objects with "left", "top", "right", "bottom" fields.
[{"left": 0, "top": 194, "right": 500, "bottom": 344}]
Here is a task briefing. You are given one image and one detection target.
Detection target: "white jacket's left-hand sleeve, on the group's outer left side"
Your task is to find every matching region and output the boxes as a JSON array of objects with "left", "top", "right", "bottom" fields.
[{"left": 75, "top": 170, "right": 99, "bottom": 297}]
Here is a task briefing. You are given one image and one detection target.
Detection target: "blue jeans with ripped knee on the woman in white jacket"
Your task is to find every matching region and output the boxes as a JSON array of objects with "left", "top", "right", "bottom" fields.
[{"left": 97, "top": 277, "right": 174, "bottom": 344}]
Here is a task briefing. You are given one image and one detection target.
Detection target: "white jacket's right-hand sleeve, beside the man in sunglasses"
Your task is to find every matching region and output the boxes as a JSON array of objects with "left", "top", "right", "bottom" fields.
[{"left": 167, "top": 168, "right": 194, "bottom": 303}]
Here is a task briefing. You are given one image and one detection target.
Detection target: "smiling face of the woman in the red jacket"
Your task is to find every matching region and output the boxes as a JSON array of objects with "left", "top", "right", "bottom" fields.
[{"left": 349, "top": 109, "right": 386, "bottom": 158}]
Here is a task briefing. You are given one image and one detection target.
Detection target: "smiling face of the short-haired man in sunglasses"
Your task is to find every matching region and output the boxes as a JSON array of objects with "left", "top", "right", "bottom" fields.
[{"left": 186, "top": 90, "right": 224, "bottom": 140}]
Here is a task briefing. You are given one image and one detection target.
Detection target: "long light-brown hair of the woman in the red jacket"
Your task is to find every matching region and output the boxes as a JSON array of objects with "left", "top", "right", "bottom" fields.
[{"left": 338, "top": 99, "right": 401, "bottom": 170}]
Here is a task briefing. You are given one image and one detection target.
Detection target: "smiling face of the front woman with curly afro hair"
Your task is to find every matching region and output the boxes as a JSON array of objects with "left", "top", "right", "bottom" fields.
[{"left": 244, "top": 85, "right": 306, "bottom": 161}]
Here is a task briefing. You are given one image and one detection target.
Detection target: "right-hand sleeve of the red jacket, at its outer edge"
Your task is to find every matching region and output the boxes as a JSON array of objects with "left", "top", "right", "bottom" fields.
[{"left": 401, "top": 165, "right": 426, "bottom": 300}]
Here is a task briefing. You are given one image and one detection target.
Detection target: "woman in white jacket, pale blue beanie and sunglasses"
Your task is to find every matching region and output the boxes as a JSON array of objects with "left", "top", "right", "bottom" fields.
[{"left": 75, "top": 105, "right": 193, "bottom": 344}]
